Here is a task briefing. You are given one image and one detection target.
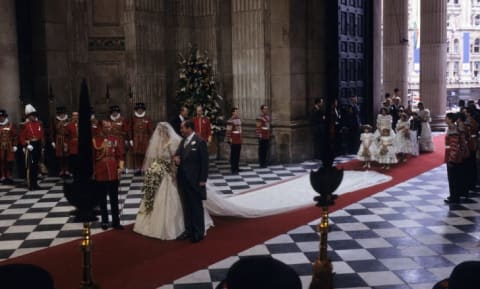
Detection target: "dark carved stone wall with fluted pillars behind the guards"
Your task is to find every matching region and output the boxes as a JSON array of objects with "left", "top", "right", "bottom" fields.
[{"left": 15, "top": 0, "right": 326, "bottom": 162}]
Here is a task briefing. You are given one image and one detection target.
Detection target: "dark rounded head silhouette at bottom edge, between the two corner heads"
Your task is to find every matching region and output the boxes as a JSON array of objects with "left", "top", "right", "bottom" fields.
[{"left": 216, "top": 256, "right": 302, "bottom": 289}]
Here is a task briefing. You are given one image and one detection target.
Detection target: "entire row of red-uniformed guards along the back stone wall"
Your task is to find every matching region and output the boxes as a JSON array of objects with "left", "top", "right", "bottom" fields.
[{"left": 0, "top": 102, "right": 270, "bottom": 190}]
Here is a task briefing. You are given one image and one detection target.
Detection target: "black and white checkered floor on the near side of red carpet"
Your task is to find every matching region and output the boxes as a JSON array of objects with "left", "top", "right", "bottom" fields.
[{"left": 160, "top": 166, "right": 480, "bottom": 289}]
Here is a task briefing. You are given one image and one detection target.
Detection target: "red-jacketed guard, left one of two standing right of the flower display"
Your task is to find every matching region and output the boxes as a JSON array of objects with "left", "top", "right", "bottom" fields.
[{"left": 225, "top": 107, "right": 242, "bottom": 174}]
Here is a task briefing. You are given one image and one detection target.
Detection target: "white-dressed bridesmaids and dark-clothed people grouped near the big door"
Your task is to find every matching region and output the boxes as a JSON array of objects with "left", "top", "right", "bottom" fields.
[{"left": 310, "top": 89, "right": 434, "bottom": 169}]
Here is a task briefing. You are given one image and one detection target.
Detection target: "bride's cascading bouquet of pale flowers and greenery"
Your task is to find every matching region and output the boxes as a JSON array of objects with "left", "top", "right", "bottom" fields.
[{"left": 142, "top": 159, "right": 172, "bottom": 214}]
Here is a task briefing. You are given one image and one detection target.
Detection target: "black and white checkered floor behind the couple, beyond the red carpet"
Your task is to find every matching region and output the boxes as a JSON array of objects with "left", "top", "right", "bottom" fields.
[{"left": 0, "top": 156, "right": 353, "bottom": 261}]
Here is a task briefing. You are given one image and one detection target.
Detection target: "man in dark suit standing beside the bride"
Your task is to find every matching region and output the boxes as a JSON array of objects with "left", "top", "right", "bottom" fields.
[{"left": 174, "top": 120, "right": 208, "bottom": 242}]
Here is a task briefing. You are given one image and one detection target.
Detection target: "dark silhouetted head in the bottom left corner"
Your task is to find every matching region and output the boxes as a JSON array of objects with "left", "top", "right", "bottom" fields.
[{"left": 0, "top": 264, "right": 55, "bottom": 289}]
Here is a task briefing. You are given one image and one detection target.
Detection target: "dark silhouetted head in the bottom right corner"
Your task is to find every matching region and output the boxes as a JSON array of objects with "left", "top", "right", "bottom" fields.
[{"left": 432, "top": 261, "right": 480, "bottom": 289}]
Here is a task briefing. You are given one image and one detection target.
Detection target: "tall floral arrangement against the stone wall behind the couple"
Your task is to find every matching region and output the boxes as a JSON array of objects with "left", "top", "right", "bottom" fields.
[{"left": 177, "top": 44, "right": 223, "bottom": 132}]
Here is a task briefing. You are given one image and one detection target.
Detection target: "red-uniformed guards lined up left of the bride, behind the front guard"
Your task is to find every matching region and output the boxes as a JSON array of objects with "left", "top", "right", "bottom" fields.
[{"left": 0, "top": 102, "right": 153, "bottom": 190}]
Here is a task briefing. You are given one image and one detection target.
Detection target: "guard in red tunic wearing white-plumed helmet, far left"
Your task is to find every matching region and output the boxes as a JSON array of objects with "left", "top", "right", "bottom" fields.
[{"left": 20, "top": 104, "right": 45, "bottom": 191}]
